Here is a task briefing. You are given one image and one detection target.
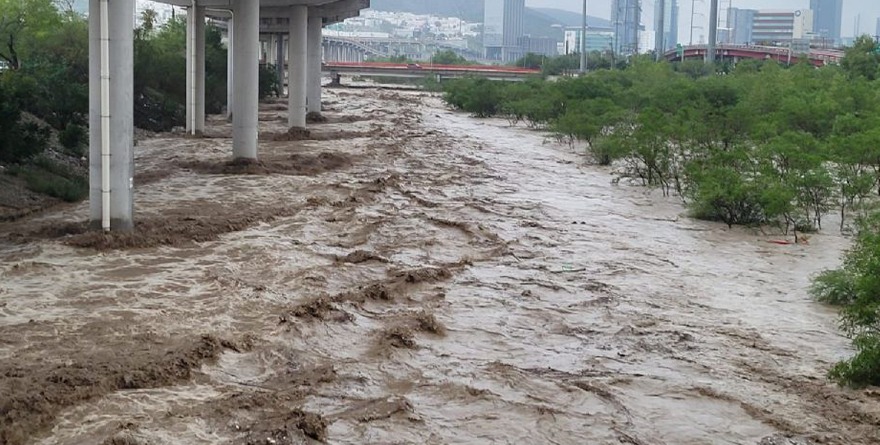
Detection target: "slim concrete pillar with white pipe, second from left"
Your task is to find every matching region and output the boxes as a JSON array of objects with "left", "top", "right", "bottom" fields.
[{"left": 186, "top": 6, "right": 205, "bottom": 135}]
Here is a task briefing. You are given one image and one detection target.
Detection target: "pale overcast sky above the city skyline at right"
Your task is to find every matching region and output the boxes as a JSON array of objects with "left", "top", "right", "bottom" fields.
[{"left": 526, "top": 0, "right": 880, "bottom": 43}]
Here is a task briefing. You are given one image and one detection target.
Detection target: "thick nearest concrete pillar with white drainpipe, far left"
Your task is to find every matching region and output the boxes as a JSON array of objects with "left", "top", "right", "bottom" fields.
[{"left": 89, "top": 0, "right": 134, "bottom": 232}]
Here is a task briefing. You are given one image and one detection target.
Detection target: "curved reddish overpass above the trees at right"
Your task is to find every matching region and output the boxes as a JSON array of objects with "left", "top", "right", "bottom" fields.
[{"left": 664, "top": 44, "right": 844, "bottom": 67}]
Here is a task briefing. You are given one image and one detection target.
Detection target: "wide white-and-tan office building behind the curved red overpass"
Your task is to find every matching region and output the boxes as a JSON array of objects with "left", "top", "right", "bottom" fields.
[{"left": 751, "top": 9, "right": 813, "bottom": 45}]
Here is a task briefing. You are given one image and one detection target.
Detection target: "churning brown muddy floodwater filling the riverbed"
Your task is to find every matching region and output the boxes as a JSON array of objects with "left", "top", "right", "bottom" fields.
[{"left": 0, "top": 89, "right": 880, "bottom": 445}]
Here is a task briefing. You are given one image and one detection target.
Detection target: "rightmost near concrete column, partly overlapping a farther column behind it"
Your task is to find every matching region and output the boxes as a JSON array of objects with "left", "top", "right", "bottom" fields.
[{"left": 287, "top": 5, "right": 309, "bottom": 128}]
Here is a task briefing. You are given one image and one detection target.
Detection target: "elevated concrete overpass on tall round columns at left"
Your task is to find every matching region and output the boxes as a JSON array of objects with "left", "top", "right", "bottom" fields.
[{"left": 89, "top": 0, "right": 370, "bottom": 231}]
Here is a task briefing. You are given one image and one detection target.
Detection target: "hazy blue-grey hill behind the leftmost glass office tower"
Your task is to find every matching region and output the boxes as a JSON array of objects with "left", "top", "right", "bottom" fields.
[{"left": 370, "top": 0, "right": 610, "bottom": 41}]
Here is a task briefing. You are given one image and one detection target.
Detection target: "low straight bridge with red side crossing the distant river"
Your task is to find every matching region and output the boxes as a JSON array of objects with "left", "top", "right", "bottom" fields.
[{"left": 323, "top": 62, "right": 541, "bottom": 81}]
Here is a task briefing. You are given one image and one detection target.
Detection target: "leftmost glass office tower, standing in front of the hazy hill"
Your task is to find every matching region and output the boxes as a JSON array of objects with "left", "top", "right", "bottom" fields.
[{"left": 483, "top": 0, "right": 526, "bottom": 62}]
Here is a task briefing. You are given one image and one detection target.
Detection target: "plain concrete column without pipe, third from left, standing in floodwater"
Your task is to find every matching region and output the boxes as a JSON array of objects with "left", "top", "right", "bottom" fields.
[{"left": 232, "top": 0, "right": 260, "bottom": 159}]
